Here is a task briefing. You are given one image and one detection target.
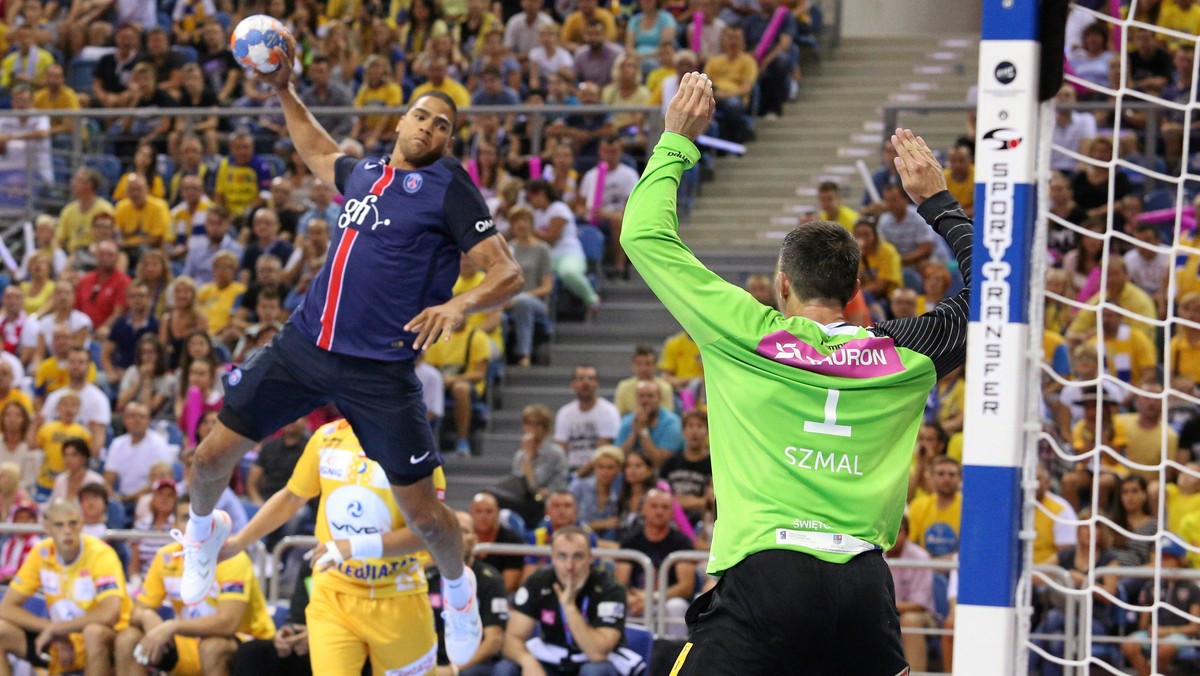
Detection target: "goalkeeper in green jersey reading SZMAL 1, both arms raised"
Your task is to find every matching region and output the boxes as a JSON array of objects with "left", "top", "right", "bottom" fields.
[{"left": 620, "top": 73, "right": 972, "bottom": 676}]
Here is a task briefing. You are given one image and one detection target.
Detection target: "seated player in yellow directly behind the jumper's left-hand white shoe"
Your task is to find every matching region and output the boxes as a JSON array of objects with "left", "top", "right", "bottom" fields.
[{"left": 116, "top": 496, "right": 275, "bottom": 676}]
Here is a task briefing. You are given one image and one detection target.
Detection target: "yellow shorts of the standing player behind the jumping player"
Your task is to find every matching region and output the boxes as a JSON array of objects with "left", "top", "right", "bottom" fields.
[{"left": 305, "top": 585, "right": 438, "bottom": 676}]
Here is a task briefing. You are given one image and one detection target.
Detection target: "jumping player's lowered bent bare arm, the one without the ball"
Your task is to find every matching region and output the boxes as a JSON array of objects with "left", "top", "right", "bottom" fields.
[{"left": 404, "top": 235, "right": 524, "bottom": 349}]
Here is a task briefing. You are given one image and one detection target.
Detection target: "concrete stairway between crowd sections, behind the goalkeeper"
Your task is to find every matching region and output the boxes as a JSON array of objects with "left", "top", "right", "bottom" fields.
[{"left": 436, "top": 31, "right": 978, "bottom": 508}]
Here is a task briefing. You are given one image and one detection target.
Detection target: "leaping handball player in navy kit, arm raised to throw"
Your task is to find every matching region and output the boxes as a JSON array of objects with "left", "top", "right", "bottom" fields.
[{"left": 174, "top": 31, "right": 522, "bottom": 663}]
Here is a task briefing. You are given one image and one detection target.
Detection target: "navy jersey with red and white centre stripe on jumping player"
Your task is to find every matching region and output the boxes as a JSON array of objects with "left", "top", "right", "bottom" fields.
[{"left": 292, "top": 156, "right": 497, "bottom": 361}]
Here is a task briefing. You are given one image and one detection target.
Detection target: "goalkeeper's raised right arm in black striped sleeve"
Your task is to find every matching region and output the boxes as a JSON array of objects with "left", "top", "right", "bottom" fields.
[{"left": 875, "top": 128, "right": 974, "bottom": 378}]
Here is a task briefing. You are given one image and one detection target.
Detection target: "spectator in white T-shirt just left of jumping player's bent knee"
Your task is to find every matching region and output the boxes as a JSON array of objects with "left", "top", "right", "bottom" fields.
[{"left": 103, "top": 401, "right": 176, "bottom": 507}]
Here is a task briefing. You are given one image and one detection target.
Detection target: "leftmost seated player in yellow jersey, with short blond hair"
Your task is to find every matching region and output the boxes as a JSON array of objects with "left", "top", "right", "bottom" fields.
[{"left": 0, "top": 499, "right": 133, "bottom": 676}]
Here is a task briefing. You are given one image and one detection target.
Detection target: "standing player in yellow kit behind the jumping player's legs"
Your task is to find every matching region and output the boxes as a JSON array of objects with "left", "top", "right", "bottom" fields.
[{"left": 221, "top": 420, "right": 445, "bottom": 676}]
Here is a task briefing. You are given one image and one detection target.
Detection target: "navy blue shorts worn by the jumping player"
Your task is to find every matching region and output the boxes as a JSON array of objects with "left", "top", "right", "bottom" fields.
[{"left": 218, "top": 324, "right": 442, "bottom": 486}]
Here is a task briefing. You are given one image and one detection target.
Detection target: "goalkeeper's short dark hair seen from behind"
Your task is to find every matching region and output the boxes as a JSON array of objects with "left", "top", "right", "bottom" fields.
[{"left": 779, "top": 221, "right": 860, "bottom": 306}]
